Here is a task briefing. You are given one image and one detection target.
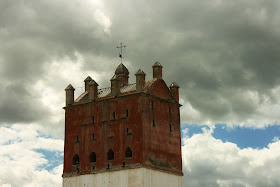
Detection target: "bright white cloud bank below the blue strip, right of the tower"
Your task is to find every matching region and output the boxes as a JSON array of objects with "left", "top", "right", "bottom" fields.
[{"left": 182, "top": 130, "right": 280, "bottom": 187}]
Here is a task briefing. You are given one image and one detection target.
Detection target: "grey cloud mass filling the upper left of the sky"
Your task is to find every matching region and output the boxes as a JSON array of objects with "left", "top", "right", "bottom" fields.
[{"left": 0, "top": 1, "right": 114, "bottom": 124}]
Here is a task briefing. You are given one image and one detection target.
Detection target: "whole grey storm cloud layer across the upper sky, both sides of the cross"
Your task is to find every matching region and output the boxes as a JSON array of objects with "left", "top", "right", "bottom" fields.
[{"left": 0, "top": 0, "right": 280, "bottom": 123}]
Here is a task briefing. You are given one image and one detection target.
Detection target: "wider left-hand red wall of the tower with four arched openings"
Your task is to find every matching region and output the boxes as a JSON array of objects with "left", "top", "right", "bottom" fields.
[{"left": 64, "top": 95, "right": 142, "bottom": 173}]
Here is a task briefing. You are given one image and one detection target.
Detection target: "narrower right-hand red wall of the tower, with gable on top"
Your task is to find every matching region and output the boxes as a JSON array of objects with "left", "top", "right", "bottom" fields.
[{"left": 142, "top": 81, "right": 182, "bottom": 171}]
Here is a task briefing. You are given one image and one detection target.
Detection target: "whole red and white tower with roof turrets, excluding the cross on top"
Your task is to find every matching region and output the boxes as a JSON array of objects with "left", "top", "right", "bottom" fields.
[{"left": 63, "top": 62, "right": 183, "bottom": 187}]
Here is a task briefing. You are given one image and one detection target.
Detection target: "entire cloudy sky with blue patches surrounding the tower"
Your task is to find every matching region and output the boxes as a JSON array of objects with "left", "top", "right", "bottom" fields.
[{"left": 0, "top": 0, "right": 280, "bottom": 187}]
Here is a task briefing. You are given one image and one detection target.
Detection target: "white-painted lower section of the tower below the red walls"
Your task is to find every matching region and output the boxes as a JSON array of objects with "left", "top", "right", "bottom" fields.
[{"left": 63, "top": 168, "right": 183, "bottom": 187}]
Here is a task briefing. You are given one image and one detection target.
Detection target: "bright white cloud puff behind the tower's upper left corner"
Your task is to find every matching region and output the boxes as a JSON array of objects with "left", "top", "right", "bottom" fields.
[{"left": 31, "top": 53, "right": 101, "bottom": 138}]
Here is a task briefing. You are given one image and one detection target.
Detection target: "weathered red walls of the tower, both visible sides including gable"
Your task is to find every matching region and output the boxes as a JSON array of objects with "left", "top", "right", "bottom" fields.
[{"left": 63, "top": 80, "right": 182, "bottom": 173}]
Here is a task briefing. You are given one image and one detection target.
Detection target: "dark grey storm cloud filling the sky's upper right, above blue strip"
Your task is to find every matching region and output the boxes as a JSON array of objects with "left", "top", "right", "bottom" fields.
[{"left": 101, "top": 1, "right": 280, "bottom": 122}]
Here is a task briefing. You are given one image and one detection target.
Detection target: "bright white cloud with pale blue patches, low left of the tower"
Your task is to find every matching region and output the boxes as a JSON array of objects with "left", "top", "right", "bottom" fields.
[{"left": 0, "top": 125, "right": 64, "bottom": 187}]
